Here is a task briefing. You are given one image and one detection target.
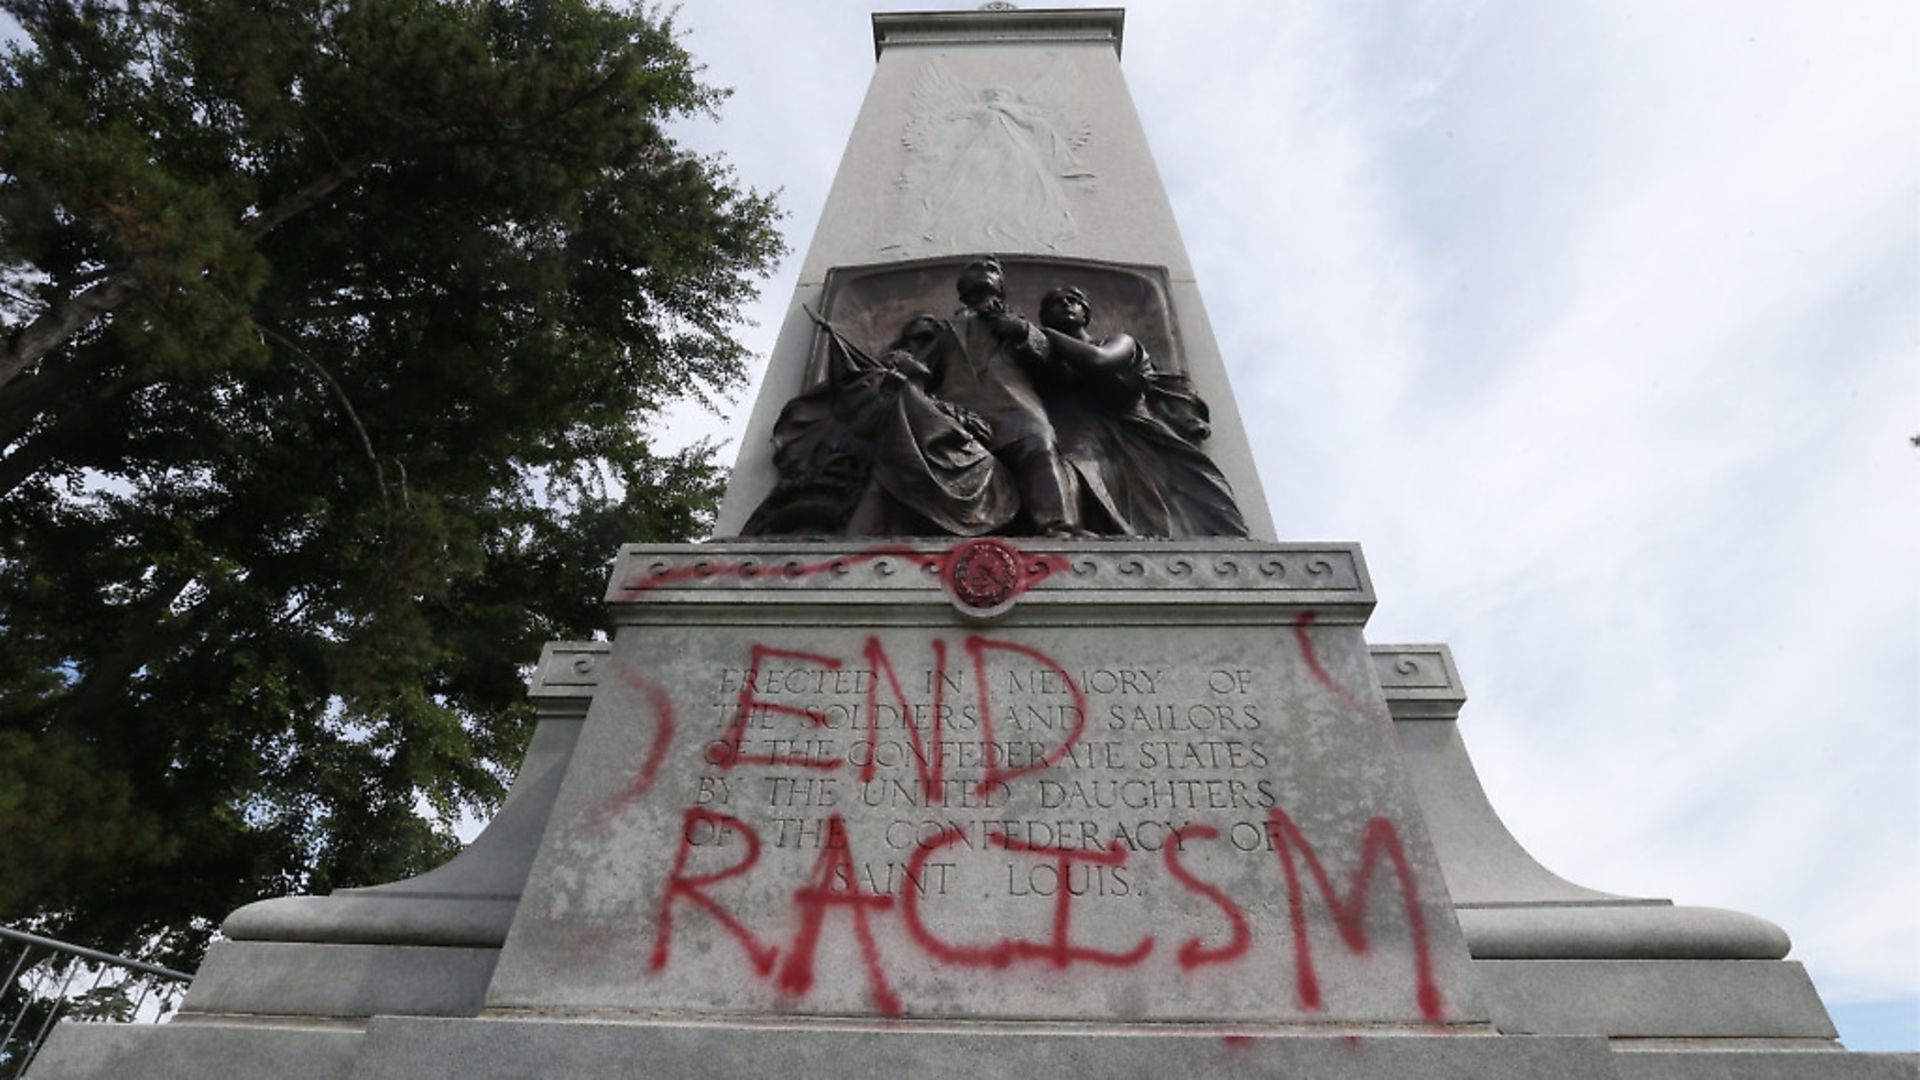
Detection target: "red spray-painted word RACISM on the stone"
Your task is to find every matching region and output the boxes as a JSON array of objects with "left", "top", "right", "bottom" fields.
[{"left": 649, "top": 807, "right": 1444, "bottom": 1022}]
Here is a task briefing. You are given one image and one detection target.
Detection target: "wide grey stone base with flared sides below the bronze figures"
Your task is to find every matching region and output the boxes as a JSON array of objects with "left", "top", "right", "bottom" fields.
[{"left": 31, "top": 542, "right": 1920, "bottom": 1080}]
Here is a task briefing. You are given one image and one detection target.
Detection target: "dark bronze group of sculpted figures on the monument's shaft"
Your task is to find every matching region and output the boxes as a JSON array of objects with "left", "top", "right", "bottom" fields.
[{"left": 743, "top": 256, "right": 1246, "bottom": 538}]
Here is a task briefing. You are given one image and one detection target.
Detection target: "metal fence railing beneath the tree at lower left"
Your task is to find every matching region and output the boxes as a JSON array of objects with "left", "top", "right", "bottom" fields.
[{"left": 0, "top": 926, "right": 192, "bottom": 1080}]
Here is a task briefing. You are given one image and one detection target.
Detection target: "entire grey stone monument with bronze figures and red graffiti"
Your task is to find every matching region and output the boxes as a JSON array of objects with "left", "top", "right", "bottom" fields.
[{"left": 33, "top": 6, "right": 1914, "bottom": 1080}]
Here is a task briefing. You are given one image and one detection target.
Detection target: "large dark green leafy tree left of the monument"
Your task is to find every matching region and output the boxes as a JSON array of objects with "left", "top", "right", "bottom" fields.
[{"left": 0, "top": 0, "right": 780, "bottom": 967}]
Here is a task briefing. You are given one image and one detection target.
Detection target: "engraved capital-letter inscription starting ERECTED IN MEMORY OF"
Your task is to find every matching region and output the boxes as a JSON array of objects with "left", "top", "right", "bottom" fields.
[{"left": 695, "top": 634, "right": 1279, "bottom": 896}]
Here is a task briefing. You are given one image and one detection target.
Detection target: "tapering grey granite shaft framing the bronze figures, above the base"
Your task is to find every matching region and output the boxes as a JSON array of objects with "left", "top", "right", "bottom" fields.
[{"left": 716, "top": 8, "right": 1275, "bottom": 540}]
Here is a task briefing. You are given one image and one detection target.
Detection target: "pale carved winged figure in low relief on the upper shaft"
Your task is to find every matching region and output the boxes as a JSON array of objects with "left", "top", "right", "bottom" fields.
[{"left": 883, "top": 52, "right": 1094, "bottom": 252}]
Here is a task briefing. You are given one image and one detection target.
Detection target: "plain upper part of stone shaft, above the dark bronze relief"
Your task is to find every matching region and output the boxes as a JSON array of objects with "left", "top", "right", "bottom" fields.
[{"left": 801, "top": 10, "right": 1167, "bottom": 281}]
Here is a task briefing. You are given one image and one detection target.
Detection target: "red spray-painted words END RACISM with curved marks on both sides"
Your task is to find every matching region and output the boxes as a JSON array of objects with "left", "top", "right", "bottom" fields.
[{"left": 616, "top": 613, "right": 1444, "bottom": 1022}]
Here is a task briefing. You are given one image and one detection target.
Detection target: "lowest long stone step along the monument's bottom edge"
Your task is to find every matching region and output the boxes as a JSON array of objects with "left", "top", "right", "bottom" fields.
[{"left": 33, "top": 1017, "right": 1916, "bottom": 1080}]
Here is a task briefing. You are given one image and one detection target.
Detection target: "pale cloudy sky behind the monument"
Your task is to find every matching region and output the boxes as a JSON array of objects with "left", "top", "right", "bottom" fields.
[{"left": 660, "top": 0, "right": 1920, "bottom": 1047}]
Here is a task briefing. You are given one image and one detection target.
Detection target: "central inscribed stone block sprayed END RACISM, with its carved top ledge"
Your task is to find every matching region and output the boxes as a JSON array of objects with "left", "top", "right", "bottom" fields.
[{"left": 488, "top": 542, "right": 1484, "bottom": 1024}]
